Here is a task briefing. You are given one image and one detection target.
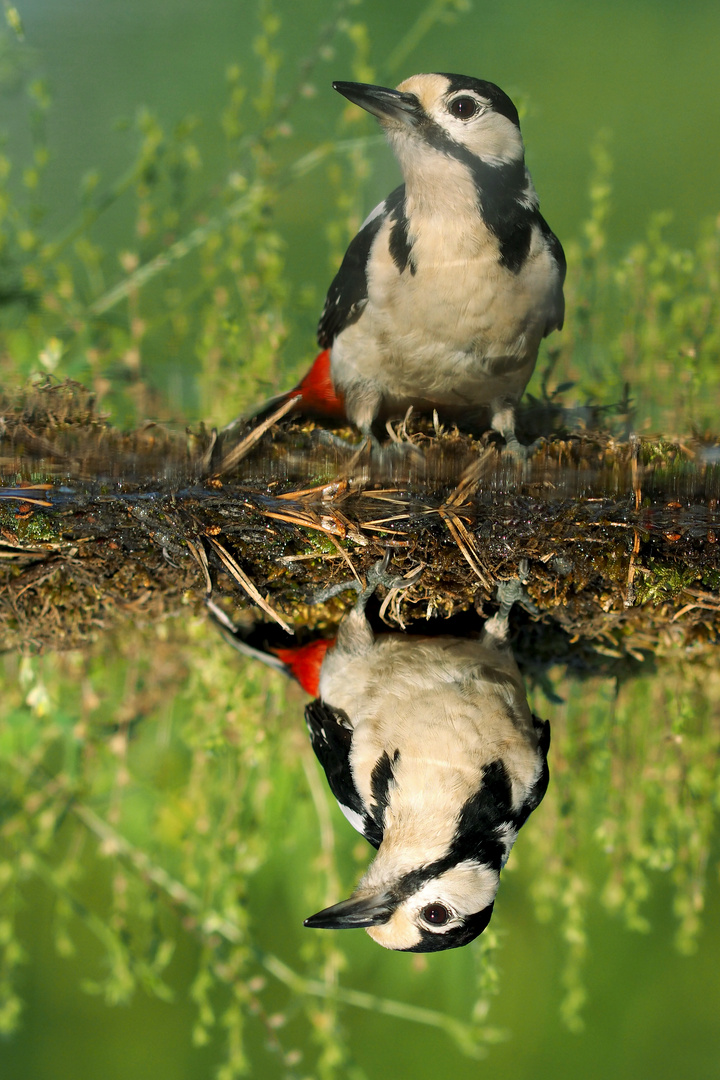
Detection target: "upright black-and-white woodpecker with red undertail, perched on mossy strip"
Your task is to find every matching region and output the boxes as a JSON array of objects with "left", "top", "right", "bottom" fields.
[{"left": 262, "top": 73, "right": 566, "bottom": 456}]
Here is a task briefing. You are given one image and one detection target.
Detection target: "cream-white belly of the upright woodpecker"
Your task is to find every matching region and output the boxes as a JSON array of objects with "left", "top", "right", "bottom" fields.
[{"left": 332, "top": 247, "right": 554, "bottom": 408}]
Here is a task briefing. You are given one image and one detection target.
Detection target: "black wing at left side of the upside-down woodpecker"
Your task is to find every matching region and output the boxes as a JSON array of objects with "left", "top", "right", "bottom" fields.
[{"left": 305, "top": 698, "right": 382, "bottom": 848}]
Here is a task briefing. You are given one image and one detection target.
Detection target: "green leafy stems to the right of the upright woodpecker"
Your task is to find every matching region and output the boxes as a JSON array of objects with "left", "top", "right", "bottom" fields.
[{"left": 544, "top": 134, "right": 720, "bottom": 437}]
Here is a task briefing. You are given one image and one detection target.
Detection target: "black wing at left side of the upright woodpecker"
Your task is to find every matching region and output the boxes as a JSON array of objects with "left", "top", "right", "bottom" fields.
[{"left": 317, "top": 184, "right": 405, "bottom": 349}]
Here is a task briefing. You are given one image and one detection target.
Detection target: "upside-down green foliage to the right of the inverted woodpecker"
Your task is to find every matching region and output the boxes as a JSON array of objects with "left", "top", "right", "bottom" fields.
[{"left": 526, "top": 660, "right": 720, "bottom": 1029}]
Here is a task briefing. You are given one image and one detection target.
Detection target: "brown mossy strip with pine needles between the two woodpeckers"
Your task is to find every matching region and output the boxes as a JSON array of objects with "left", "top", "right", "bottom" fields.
[{"left": 0, "top": 382, "right": 720, "bottom": 670}]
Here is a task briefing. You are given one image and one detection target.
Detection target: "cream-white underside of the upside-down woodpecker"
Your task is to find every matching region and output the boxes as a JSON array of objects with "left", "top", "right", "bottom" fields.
[{"left": 320, "top": 634, "right": 538, "bottom": 820}]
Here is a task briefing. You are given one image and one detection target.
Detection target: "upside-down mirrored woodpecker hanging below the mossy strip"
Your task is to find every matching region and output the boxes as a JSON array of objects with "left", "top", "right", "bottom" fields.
[{"left": 215, "top": 561, "right": 549, "bottom": 953}]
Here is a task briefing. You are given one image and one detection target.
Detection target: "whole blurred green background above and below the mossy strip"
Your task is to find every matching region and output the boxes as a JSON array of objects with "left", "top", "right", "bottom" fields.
[{"left": 0, "top": 0, "right": 720, "bottom": 1080}]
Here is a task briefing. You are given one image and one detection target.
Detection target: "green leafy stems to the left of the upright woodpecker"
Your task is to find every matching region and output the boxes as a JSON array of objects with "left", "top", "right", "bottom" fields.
[{"left": 0, "top": 0, "right": 386, "bottom": 422}]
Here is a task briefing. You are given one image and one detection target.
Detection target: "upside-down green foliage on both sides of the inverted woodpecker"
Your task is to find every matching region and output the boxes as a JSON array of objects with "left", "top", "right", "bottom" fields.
[{"left": 0, "top": 623, "right": 720, "bottom": 1078}]
